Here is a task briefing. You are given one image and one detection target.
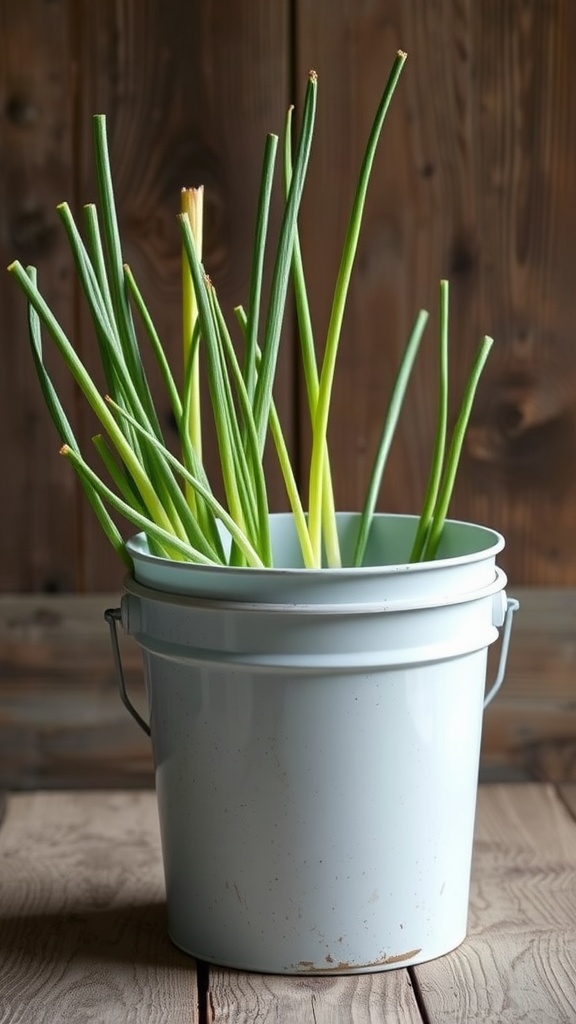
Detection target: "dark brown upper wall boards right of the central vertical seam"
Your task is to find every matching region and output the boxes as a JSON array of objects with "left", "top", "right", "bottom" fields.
[{"left": 296, "top": 0, "right": 576, "bottom": 585}]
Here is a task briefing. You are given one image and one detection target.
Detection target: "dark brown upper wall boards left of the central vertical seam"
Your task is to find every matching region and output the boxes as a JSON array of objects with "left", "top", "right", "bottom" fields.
[{"left": 0, "top": 0, "right": 295, "bottom": 592}]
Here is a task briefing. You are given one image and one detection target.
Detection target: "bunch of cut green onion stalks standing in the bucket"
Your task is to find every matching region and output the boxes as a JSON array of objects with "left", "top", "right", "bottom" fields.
[{"left": 8, "top": 51, "right": 492, "bottom": 568}]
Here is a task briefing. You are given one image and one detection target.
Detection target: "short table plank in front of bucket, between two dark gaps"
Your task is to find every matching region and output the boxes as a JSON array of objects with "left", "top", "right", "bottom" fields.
[{"left": 204, "top": 968, "right": 421, "bottom": 1024}]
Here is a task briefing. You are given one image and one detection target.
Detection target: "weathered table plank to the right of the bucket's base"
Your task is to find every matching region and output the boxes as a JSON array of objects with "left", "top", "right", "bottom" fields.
[{"left": 415, "top": 784, "right": 576, "bottom": 1024}]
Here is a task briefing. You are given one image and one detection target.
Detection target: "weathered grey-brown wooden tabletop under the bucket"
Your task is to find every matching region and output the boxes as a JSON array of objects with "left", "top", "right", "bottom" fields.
[{"left": 0, "top": 783, "right": 576, "bottom": 1024}]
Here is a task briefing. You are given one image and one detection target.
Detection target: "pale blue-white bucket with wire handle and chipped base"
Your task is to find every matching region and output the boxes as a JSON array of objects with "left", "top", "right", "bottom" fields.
[{"left": 107, "top": 514, "right": 518, "bottom": 975}]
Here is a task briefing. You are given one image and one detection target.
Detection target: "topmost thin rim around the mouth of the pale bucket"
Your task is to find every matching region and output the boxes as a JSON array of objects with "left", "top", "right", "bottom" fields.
[{"left": 125, "top": 512, "right": 505, "bottom": 582}]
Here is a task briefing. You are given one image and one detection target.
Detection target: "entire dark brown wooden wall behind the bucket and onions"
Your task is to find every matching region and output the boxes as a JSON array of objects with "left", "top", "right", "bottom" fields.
[{"left": 0, "top": 0, "right": 576, "bottom": 784}]
